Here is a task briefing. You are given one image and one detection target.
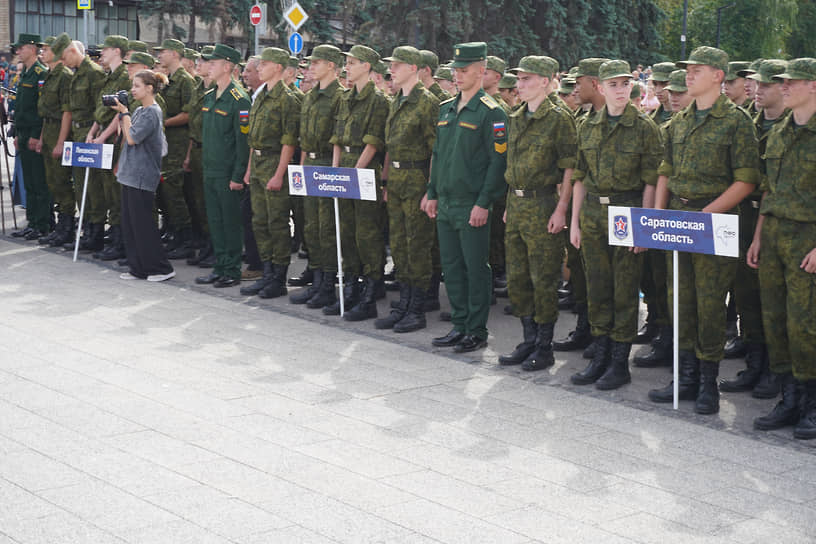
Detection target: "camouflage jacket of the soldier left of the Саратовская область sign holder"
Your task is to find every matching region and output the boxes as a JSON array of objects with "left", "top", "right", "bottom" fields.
[{"left": 572, "top": 104, "right": 663, "bottom": 196}]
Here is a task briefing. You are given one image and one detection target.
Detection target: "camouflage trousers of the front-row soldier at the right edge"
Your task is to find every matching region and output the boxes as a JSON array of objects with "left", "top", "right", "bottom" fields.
[{"left": 759, "top": 215, "right": 816, "bottom": 381}]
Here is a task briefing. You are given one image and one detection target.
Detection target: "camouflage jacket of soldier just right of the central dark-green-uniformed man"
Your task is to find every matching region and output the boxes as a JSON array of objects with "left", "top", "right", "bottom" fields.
[{"left": 504, "top": 100, "right": 577, "bottom": 189}]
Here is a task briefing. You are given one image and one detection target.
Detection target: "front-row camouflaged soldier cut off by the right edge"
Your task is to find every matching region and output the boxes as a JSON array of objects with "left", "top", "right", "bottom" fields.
[{"left": 748, "top": 58, "right": 816, "bottom": 440}]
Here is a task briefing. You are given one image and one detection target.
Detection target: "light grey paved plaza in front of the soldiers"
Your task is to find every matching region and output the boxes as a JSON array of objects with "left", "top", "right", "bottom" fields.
[{"left": 0, "top": 203, "right": 816, "bottom": 544}]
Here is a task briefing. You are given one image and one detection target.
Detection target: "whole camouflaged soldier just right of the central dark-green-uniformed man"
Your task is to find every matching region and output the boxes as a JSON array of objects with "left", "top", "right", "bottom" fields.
[{"left": 499, "top": 56, "right": 577, "bottom": 370}]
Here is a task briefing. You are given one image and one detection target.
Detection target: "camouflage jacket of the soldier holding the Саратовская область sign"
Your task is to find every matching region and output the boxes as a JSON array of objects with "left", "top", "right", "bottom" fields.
[{"left": 658, "top": 95, "right": 759, "bottom": 199}]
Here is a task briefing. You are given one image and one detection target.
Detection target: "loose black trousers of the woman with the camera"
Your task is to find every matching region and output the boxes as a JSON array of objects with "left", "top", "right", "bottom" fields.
[{"left": 122, "top": 185, "right": 173, "bottom": 279}]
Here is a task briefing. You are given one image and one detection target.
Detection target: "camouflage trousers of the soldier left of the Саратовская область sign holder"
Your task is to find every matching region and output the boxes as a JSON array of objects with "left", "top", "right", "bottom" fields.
[{"left": 580, "top": 199, "right": 643, "bottom": 343}]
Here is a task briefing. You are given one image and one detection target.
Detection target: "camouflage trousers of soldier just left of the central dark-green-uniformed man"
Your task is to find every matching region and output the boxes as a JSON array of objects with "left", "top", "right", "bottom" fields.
[{"left": 386, "top": 176, "right": 436, "bottom": 289}]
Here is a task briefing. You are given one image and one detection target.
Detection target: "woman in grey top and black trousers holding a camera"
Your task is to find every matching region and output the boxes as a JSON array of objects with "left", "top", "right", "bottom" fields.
[{"left": 112, "top": 70, "right": 176, "bottom": 281}]
